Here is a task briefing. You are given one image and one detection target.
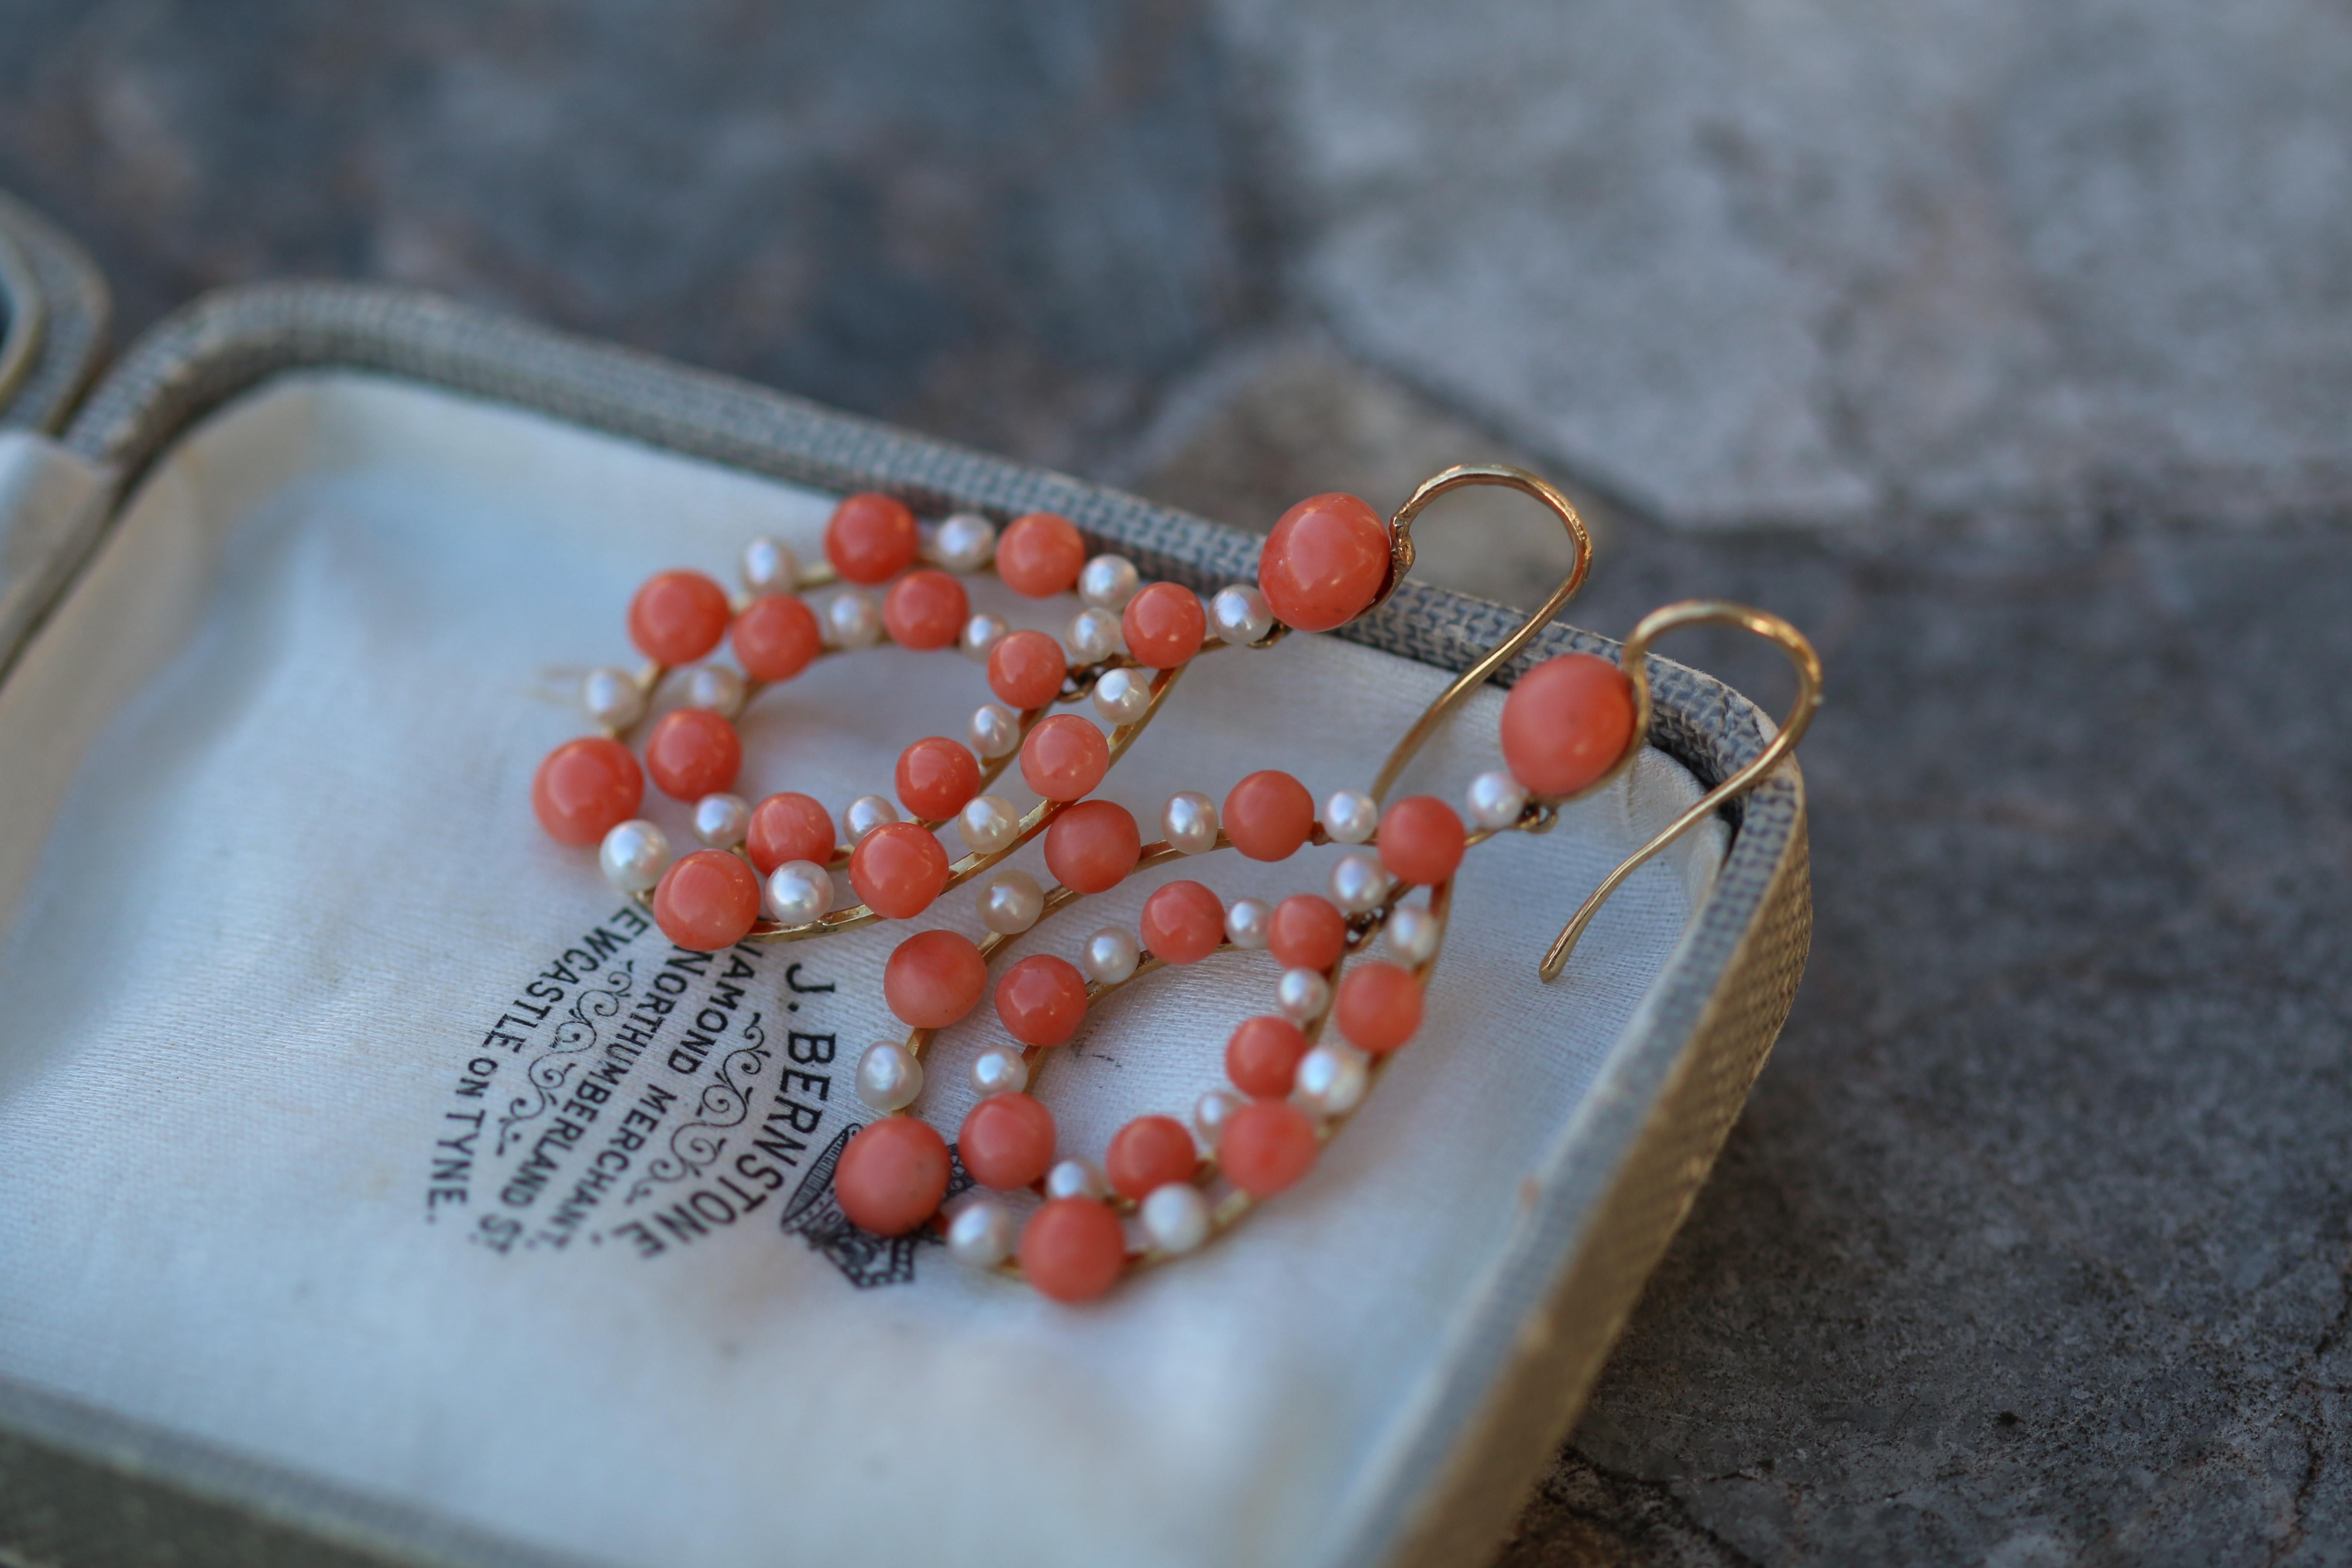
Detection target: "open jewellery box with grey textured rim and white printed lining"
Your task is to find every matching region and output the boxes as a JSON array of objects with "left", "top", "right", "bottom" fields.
[{"left": 0, "top": 196, "right": 1811, "bottom": 1566}]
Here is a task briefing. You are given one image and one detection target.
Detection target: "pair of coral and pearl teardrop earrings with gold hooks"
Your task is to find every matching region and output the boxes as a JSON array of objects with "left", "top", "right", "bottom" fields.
[{"left": 532, "top": 466, "right": 1820, "bottom": 1300}]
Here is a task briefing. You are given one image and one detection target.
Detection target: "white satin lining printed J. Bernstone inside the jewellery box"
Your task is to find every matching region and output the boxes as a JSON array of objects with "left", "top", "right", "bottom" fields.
[{"left": 0, "top": 371, "right": 1726, "bottom": 1566}]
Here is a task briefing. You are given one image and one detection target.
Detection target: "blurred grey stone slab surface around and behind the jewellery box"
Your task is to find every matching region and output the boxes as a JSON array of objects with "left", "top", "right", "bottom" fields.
[{"left": 0, "top": 0, "right": 2352, "bottom": 1568}]
